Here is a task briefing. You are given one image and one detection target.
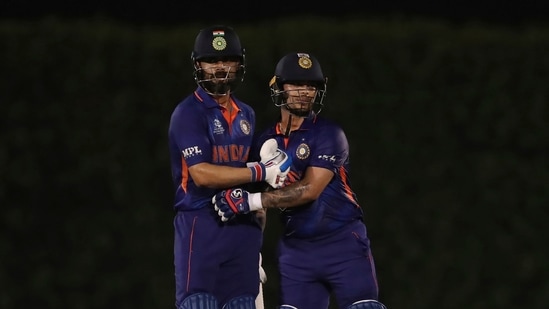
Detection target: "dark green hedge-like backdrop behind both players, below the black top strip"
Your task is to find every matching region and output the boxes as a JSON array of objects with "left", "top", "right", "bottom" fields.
[{"left": 0, "top": 18, "right": 549, "bottom": 309}]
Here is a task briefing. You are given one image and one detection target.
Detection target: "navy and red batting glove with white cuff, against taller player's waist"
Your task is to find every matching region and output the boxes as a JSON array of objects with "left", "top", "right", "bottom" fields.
[{"left": 212, "top": 188, "right": 263, "bottom": 222}]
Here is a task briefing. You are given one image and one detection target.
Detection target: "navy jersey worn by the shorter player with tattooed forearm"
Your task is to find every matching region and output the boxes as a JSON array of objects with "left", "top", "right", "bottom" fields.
[{"left": 253, "top": 117, "right": 363, "bottom": 238}]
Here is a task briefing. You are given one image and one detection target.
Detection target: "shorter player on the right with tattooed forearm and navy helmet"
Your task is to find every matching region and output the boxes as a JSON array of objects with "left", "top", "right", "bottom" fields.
[{"left": 214, "top": 52, "right": 385, "bottom": 309}]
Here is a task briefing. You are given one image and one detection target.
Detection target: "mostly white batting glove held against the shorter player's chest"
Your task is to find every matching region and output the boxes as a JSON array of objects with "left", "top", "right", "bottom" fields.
[{"left": 248, "top": 138, "right": 292, "bottom": 189}]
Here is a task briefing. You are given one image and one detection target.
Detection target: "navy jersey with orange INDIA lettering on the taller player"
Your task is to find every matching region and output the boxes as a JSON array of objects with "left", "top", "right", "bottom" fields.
[{"left": 168, "top": 87, "right": 255, "bottom": 210}]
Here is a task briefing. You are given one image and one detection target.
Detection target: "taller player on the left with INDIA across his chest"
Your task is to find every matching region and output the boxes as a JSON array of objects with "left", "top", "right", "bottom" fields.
[{"left": 168, "top": 25, "right": 290, "bottom": 309}]
